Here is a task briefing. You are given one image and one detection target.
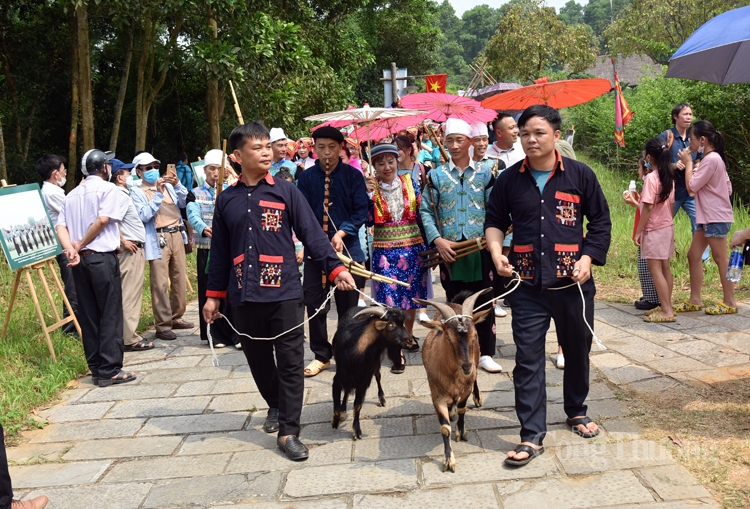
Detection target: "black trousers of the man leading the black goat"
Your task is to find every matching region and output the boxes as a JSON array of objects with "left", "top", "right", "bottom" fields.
[{"left": 234, "top": 299, "right": 305, "bottom": 436}]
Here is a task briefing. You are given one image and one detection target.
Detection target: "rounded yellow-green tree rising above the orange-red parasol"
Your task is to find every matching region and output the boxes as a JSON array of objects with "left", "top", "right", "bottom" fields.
[{"left": 485, "top": 0, "right": 596, "bottom": 81}]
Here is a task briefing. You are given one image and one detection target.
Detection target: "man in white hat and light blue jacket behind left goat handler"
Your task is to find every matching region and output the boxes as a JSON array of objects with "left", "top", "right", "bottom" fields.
[{"left": 187, "top": 149, "right": 242, "bottom": 349}]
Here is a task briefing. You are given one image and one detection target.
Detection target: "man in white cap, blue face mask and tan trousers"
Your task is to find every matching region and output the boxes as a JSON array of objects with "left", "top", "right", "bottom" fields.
[{"left": 130, "top": 152, "right": 194, "bottom": 341}]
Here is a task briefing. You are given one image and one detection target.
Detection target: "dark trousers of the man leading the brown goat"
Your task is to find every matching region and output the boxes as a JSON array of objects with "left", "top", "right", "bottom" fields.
[{"left": 508, "top": 284, "right": 596, "bottom": 445}]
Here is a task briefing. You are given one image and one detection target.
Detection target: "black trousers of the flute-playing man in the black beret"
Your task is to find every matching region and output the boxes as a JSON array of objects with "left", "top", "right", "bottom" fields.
[{"left": 303, "top": 258, "right": 364, "bottom": 362}]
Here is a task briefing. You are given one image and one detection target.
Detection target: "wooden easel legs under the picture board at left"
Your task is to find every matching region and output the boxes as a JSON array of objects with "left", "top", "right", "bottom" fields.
[{"left": 0, "top": 180, "right": 81, "bottom": 363}]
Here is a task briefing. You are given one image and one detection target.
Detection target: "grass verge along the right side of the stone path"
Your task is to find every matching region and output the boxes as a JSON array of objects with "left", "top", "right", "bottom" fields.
[{"left": 581, "top": 157, "right": 750, "bottom": 508}]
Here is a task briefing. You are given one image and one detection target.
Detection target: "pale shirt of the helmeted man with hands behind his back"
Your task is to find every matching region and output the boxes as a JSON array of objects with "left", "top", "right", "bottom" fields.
[{"left": 57, "top": 176, "right": 124, "bottom": 253}]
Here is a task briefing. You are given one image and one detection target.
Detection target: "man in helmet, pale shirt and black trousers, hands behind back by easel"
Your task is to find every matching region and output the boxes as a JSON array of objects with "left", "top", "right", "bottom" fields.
[{"left": 57, "top": 150, "right": 136, "bottom": 387}]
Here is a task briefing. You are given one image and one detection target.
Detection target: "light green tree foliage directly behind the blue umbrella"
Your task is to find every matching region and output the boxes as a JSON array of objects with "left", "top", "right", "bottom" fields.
[{"left": 604, "top": 0, "right": 750, "bottom": 64}]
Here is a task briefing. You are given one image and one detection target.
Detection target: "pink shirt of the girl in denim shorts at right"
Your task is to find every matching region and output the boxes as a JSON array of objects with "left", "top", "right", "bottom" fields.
[{"left": 690, "top": 152, "right": 734, "bottom": 224}]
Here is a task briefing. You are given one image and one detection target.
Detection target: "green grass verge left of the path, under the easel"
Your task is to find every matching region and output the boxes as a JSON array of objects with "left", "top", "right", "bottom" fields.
[{"left": 0, "top": 254, "right": 198, "bottom": 442}]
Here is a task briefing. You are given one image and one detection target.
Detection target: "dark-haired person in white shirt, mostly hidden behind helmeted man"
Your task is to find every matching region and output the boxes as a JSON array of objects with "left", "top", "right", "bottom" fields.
[{"left": 36, "top": 154, "right": 78, "bottom": 335}]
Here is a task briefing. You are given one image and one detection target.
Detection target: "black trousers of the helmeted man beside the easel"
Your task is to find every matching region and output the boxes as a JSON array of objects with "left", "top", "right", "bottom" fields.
[{"left": 73, "top": 251, "right": 124, "bottom": 378}]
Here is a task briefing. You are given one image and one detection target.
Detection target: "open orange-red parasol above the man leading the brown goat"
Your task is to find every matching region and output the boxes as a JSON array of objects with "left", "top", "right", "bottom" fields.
[{"left": 482, "top": 78, "right": 612, "bottom": 110}]
